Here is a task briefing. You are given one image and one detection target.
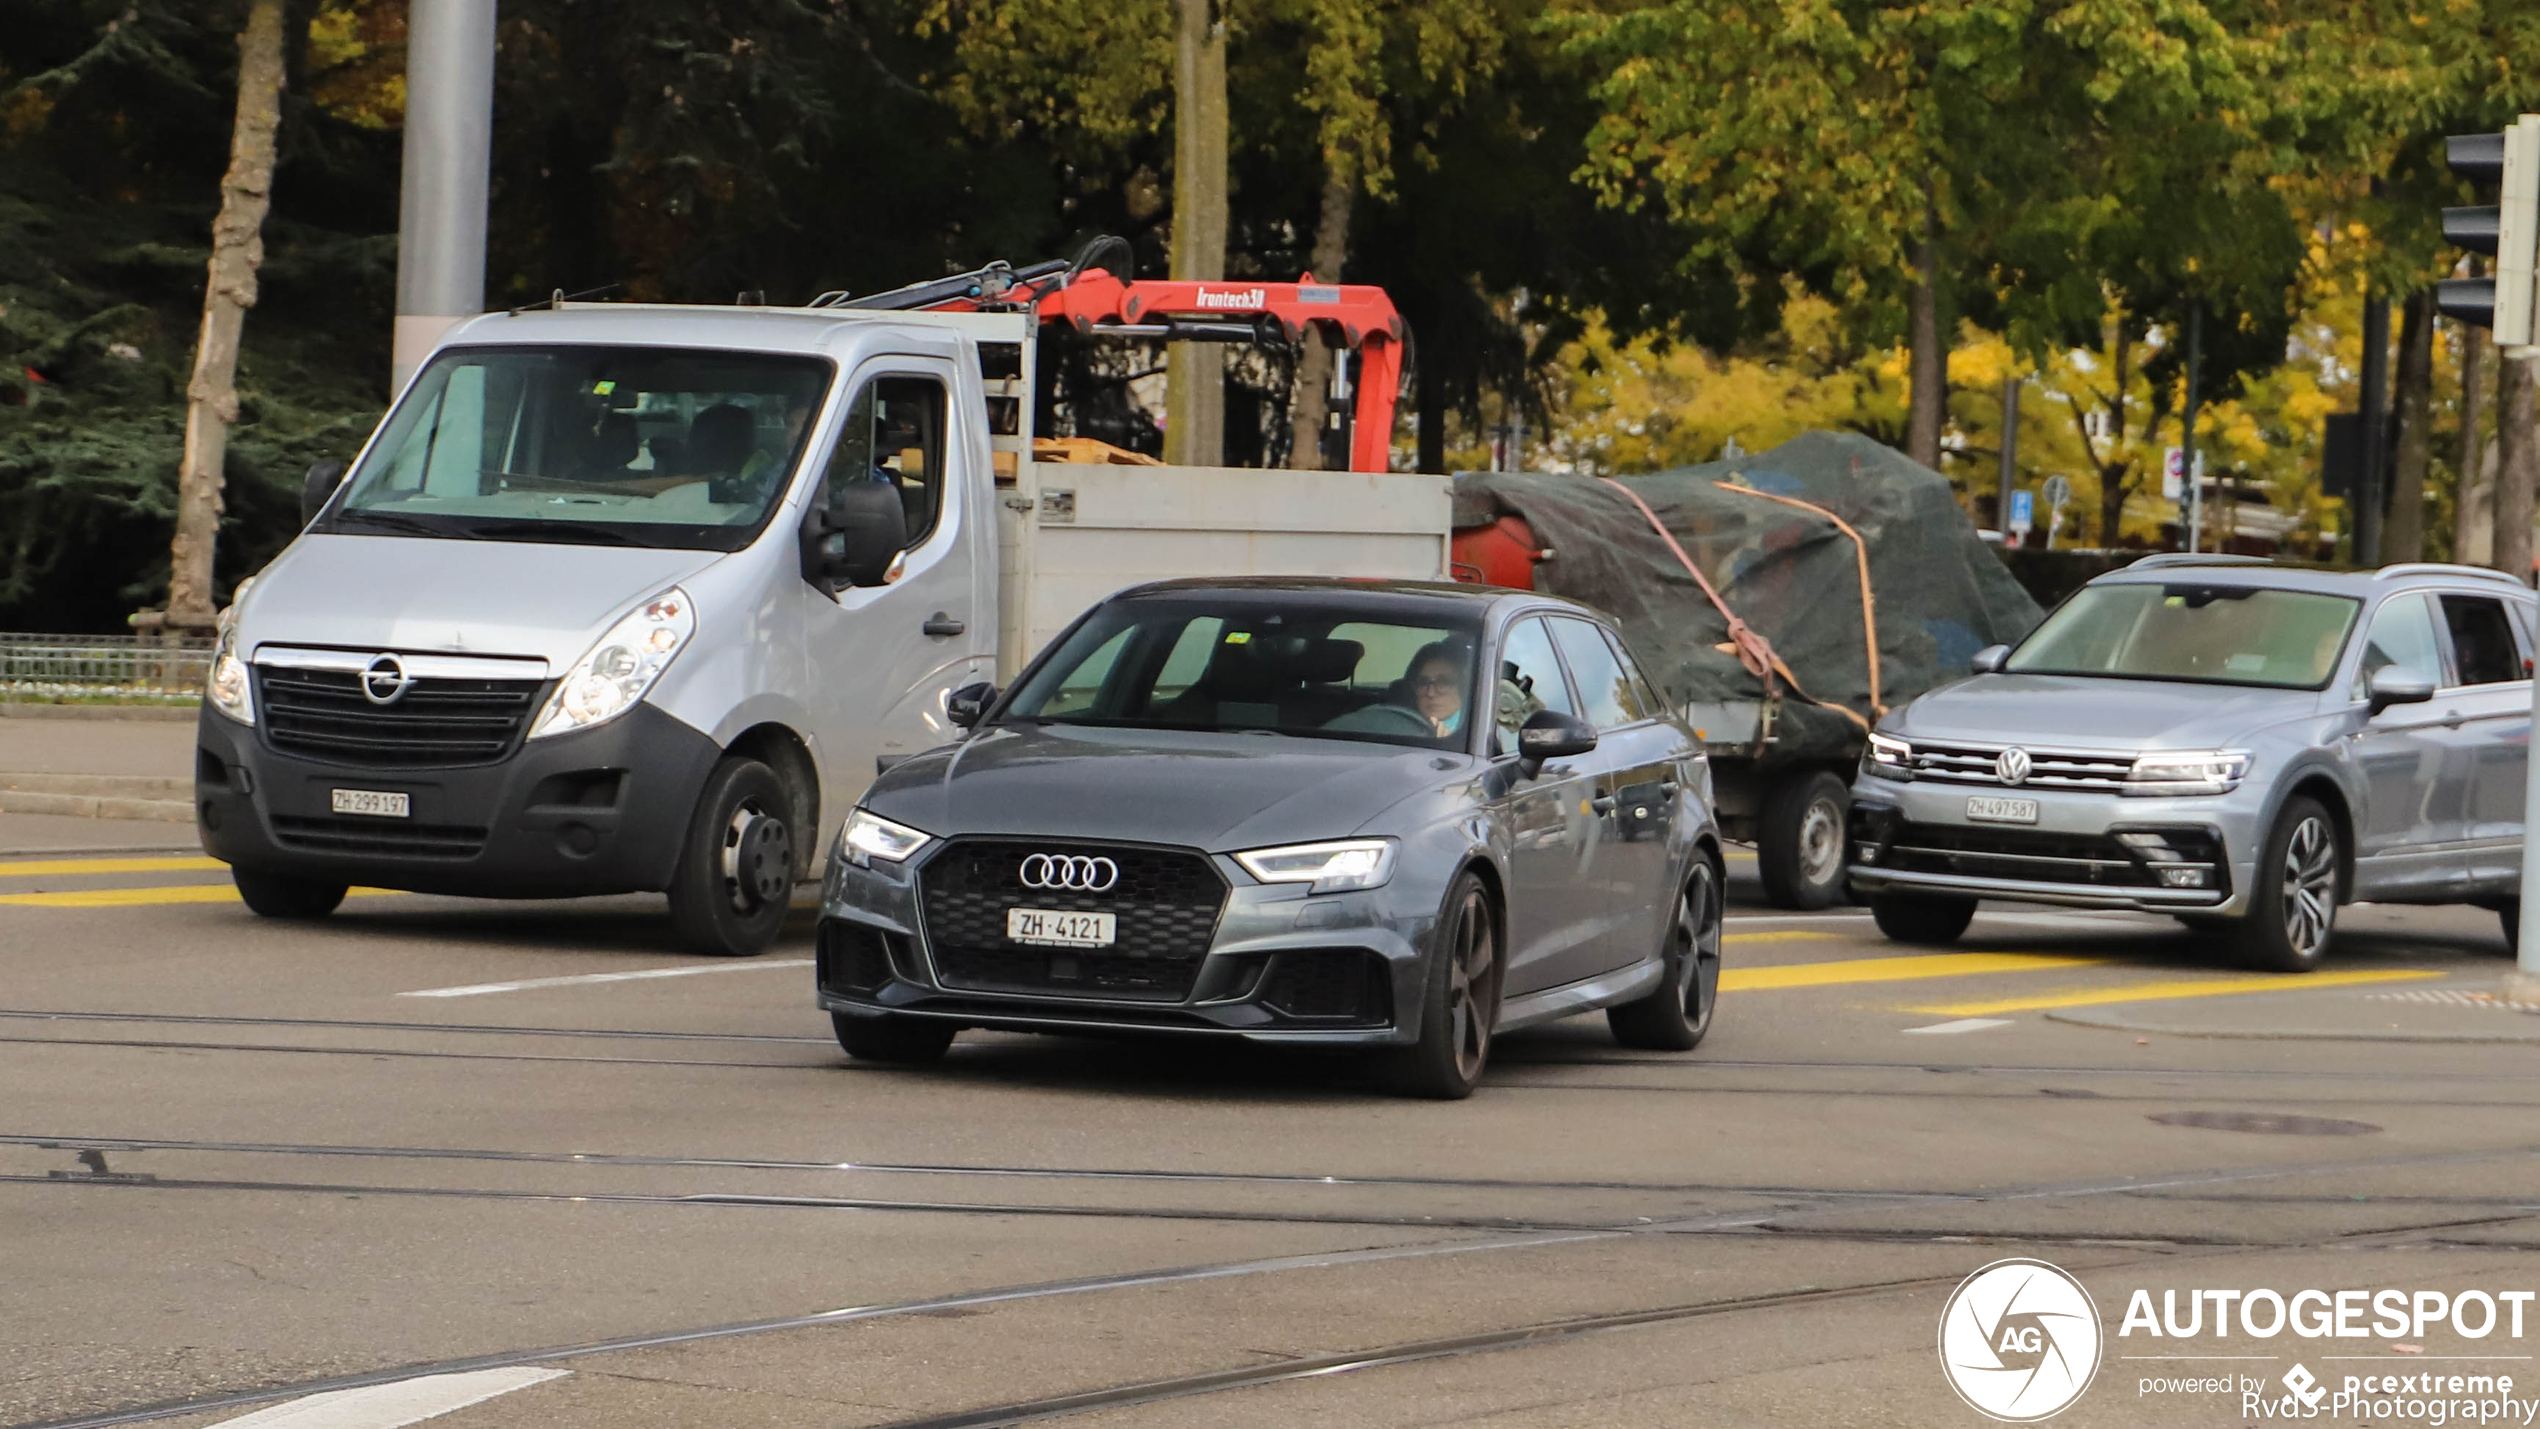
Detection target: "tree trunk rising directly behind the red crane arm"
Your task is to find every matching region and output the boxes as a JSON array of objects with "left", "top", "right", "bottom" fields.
[{"left": 1163, "top": 0, "right": 1227, "bottom": 467}]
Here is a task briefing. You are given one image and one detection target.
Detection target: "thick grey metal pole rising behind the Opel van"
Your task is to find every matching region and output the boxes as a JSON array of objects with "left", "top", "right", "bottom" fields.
[{"left": 391, "top": 0, "right": 495, "bottom": 391}]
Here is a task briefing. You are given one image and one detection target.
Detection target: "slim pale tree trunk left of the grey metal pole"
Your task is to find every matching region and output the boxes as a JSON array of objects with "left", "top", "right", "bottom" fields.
[{"left": 168, "top": 0, "right": 282, "bottom": 629}]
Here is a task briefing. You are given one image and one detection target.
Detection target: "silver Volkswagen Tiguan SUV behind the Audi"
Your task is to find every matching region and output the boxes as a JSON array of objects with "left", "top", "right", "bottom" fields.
[{"left": 1852, "top": 556, "right": 2535, "bottom": 972}]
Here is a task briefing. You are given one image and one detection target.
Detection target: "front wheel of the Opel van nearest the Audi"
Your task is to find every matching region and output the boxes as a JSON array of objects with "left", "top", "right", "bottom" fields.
[{"left": 671, "top": 759, "right": 795, "bottom": 957}]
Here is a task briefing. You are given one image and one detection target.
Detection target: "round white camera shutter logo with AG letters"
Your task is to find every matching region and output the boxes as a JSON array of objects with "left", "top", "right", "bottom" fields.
[{"left": 1941, "top": 1259, "right": 2101, "bottom": 1424}]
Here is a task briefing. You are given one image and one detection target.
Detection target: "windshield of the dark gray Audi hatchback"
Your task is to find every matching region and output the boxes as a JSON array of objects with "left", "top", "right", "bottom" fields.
[{"left": 998, "top": 596, "right": 1481, "bottom": 749}]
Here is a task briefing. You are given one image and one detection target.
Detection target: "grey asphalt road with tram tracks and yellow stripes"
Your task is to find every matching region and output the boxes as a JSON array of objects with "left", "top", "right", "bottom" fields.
[{"left": 0, "top": 825, "right": 2540, "bottom": 1429}]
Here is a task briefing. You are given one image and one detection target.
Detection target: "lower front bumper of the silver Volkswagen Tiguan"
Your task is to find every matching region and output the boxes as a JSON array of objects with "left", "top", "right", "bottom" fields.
[{"left": 1849, "top": 777, "right": 2256, "bottom": 916}]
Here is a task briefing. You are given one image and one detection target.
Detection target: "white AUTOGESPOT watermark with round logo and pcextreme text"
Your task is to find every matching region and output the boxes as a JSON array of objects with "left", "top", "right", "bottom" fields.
[{"left": 1941, "top": 1259, "right": 2540, "bottom": 1426}]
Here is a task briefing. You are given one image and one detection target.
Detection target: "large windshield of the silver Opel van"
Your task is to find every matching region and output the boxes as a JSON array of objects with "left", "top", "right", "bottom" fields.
[{"left": 318, "top": 345, "right": 833, "bottom": 551}]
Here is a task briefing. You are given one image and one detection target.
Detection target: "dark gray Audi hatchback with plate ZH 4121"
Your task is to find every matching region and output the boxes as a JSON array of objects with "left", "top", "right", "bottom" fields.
[{"left": 818, "top": 579, "right": 1722, "bottom": 1096}]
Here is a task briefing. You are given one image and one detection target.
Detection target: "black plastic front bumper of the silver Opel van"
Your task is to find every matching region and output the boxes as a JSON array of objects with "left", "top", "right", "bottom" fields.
[{"left": 193, "top": 703, "right": 721, "bottom": 899}]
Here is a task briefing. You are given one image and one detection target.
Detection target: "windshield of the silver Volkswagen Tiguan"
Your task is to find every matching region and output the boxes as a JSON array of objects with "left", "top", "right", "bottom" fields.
[{"left": 2004, "top": 581, "right": 2360, "bottom": 690}]
